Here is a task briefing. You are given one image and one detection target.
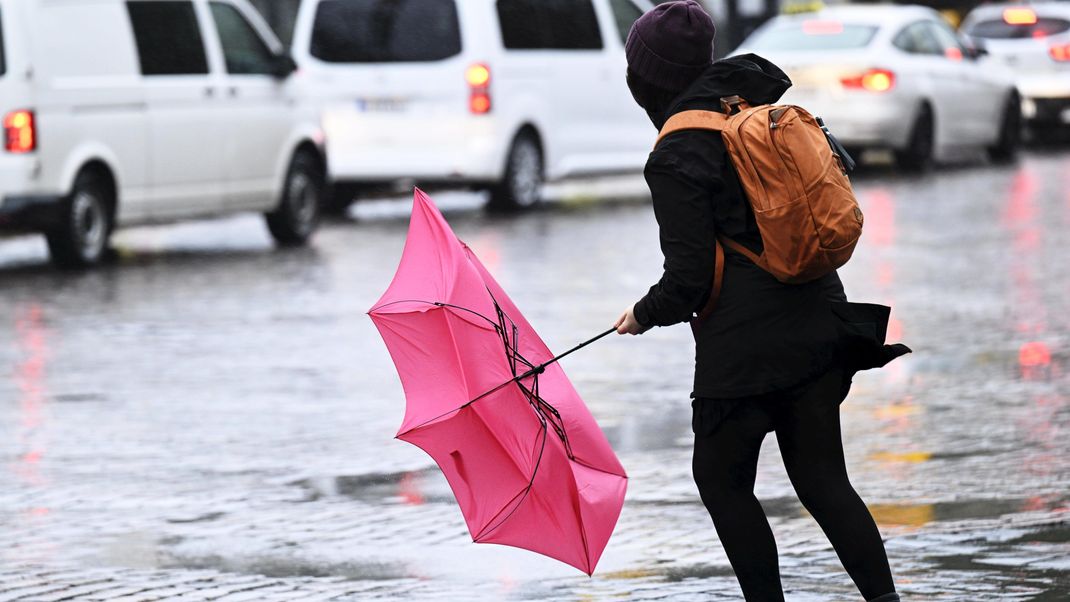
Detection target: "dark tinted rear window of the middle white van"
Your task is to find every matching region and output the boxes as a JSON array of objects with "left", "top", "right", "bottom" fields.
[{"left": 310, "top": 0, "right": 461, "bottom": 63}]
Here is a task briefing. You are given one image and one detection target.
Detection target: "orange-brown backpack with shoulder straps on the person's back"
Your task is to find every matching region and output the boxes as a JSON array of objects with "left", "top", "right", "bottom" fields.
[{"left": 655, "top": 96, "right": 862, "bottom": 321}]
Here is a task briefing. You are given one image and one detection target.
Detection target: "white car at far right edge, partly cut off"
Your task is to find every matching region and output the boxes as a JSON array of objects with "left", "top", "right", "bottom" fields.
[{"left": 961, "top": 2, "right": 1070, "bottom": 134}]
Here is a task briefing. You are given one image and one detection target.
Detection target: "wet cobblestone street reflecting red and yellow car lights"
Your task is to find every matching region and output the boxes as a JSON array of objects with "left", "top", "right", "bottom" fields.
[{"left": 0, "top": 149, "right": 1070, "bottom": 602}]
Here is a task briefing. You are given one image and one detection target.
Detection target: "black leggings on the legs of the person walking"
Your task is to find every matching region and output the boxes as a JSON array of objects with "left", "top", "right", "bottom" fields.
[{"left": 692, "top": 370, "right": 896, "bottom": 602}]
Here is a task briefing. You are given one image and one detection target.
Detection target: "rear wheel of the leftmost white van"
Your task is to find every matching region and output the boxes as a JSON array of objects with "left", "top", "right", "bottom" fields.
[{"left": 45, "top": 171, "right": 114, "bottom": 267}]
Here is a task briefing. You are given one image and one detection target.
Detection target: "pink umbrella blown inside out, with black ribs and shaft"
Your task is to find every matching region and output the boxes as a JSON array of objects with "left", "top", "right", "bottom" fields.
[{"left": 369, "top": 189, "right": 627, "bottom": 574}]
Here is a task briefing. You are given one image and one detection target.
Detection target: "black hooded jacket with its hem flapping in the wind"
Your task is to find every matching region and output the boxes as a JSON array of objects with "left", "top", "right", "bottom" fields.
[{"left": 635, "top": 55, "right": 906, "bottom": 399}]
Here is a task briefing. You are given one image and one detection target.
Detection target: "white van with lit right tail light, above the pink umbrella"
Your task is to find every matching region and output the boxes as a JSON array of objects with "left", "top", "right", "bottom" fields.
[{"left": 291, "top": 0, "right": 655, "bottom": 209}]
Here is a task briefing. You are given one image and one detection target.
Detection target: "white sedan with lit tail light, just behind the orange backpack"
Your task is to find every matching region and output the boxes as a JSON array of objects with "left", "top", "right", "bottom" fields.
[{"left": 735, "top": 5, "right": 1020, "bottom": 169}]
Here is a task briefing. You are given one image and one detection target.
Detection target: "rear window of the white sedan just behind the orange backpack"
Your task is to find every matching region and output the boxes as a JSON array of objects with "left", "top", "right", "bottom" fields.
[{"left": 745, "top": 19, "right": 877, "bottom": 50}]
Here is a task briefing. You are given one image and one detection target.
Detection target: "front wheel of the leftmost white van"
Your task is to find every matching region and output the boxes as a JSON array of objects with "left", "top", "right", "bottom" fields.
[{"left": 264, "top": 152, "right": 323, "bottom": 246}]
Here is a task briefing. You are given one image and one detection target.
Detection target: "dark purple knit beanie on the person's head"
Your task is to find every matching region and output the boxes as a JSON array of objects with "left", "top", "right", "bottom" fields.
[{"left": 624, "top": 0, "right": 717, "bottom": 91}]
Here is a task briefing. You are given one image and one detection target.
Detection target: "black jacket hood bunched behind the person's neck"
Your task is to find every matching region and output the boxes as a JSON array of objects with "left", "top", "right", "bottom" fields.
[{"left": 652, "top": 55, "right": 792, "bottom": 129}]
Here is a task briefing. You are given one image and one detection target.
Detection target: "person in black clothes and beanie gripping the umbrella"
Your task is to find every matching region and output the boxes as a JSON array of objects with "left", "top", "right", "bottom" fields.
[{"left": 616, "top": 0, "right": 910, "bottom": 602}]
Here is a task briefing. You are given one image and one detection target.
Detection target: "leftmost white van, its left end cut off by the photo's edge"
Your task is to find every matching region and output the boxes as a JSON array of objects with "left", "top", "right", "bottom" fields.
[{"left": 0, "top": 0, "right": 325, "bottom": 266}]
